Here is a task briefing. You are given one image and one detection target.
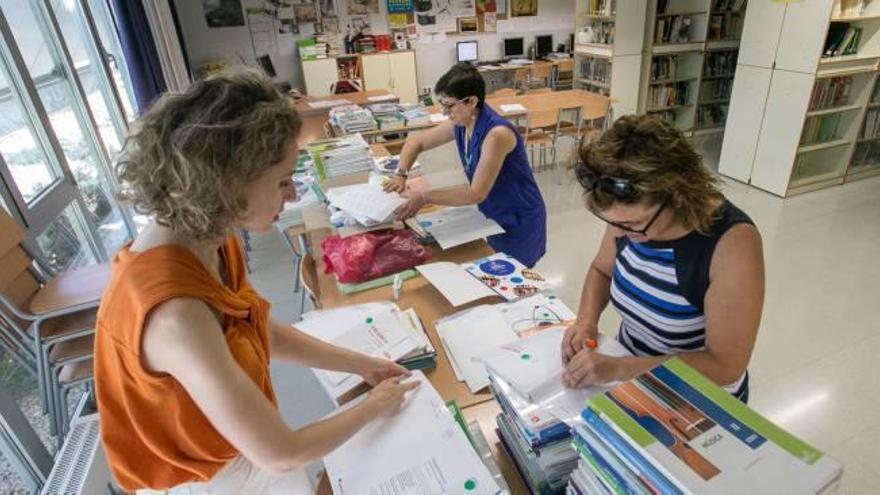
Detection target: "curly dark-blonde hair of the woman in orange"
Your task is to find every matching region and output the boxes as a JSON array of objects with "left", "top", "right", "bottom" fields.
[{"left": 116, "top": 69, "right": 302, "bottom": 240}]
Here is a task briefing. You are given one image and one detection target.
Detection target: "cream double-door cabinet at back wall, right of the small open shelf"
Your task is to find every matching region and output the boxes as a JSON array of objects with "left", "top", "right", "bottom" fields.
[{"left": 361, "top": 51, "right": 419, "bottom": 103}]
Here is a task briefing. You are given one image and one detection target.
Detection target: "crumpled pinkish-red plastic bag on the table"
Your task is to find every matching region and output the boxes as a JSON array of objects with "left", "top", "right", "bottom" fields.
[{"left": 321, "top": 230, "right": 431, "bottom": 284}]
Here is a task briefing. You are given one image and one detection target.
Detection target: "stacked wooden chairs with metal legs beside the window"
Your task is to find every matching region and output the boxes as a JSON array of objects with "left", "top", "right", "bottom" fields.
[{"left": 0, "top": 209, "right": 110, "bottom": 445}]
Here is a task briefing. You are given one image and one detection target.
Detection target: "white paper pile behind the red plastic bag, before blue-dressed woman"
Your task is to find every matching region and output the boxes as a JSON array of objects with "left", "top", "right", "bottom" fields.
[{"left": 326, "top": 183, "right": 406, "bottom": 227}]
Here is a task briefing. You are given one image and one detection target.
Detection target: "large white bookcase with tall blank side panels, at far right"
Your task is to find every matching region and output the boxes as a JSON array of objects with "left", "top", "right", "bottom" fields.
[{"left": 719, "top": 0, "right": 880, "bottom": 197}]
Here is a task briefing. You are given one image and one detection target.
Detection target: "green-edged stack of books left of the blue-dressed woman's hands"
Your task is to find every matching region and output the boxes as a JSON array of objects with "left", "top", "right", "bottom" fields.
[{"left": 307, "top": 134, "right": 373, "bottom": 181}]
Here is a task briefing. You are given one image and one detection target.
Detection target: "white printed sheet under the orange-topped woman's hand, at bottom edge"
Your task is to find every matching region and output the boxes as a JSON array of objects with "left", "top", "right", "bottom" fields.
[{"left": 324, "top": 371, "right": 500, "bottom": 495}]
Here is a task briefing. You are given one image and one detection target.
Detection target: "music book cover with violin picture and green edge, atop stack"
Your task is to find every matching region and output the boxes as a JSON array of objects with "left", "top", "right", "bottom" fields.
[{"left": 587, "top": 358, "right": 842, "bottom": 495}]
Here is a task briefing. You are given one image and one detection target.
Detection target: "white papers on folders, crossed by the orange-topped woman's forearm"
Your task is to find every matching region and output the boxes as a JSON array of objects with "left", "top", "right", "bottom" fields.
[{"left": 294, "top": 302, "right": 436, "bottom": 400}]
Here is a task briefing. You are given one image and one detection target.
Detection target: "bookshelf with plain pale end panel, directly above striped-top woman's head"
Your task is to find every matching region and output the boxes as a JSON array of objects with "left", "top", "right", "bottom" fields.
[{"left": 574, "top": 0, "right": 648, "bottom": 116}]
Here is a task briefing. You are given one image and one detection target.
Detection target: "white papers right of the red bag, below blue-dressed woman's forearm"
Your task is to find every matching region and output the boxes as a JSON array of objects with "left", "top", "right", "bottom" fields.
[{"left": 415, "top": 206, "right": 504, "bottom": 249}]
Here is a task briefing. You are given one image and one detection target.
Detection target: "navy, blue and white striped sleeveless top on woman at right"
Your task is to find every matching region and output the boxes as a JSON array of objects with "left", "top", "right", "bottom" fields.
[{"left": 611, "top": 201, "right": 754, "bottom": 401}]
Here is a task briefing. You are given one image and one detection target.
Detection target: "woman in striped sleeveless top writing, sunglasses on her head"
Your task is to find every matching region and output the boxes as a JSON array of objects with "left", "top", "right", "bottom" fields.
[{"left": 562, "top": 115, "right": 764, "bottom": 401}]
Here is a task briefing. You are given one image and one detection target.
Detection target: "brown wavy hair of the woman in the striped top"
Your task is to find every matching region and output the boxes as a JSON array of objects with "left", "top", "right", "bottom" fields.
[{"left": 576, "top": 115, "right": 724, "bottom": 234}]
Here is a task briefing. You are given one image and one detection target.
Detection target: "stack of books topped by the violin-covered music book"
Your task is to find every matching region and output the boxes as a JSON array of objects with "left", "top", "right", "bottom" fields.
[{"left": 567, "top": 358, "right": 843, "bottom": 495}]
